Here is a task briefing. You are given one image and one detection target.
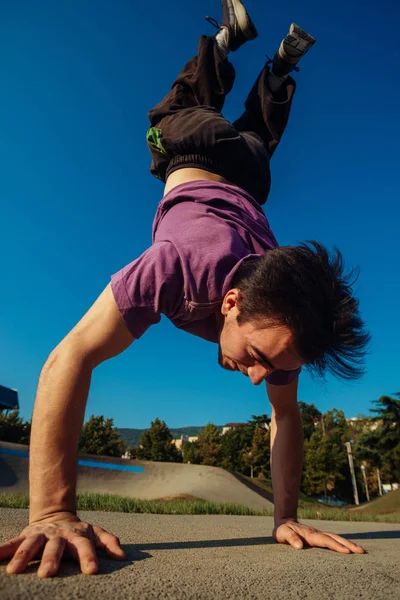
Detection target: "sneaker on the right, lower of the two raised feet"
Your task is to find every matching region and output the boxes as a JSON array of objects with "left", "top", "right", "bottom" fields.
[{"left": 272, "top": 23, "right": 315, "bottom": 77}]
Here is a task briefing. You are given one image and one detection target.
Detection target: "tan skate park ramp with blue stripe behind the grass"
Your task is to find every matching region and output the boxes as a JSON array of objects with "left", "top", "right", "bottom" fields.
[{"left": 0, "top": 442, "right": 273, "bottom": 510}]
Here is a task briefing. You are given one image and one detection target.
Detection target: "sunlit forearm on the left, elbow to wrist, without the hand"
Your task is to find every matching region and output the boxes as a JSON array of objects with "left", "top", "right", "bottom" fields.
[{"left": 29, "top": 346, "right": 92, "bottom": 522}]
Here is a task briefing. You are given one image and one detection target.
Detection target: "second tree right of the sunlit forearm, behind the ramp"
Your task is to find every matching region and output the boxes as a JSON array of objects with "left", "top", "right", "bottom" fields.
[{"left": 136, "top": 418, "right": 182, "bottom": 462}]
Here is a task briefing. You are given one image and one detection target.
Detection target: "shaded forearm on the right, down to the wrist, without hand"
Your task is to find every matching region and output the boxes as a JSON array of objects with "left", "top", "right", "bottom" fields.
[{"left": 271, "top": 407, "right": 304, "bottom": 523}]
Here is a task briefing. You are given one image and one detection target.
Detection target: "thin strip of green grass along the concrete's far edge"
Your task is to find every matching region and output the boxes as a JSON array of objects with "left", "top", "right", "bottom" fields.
[{"left": 0, "top": 493, "right": 400, "bottom": 523}]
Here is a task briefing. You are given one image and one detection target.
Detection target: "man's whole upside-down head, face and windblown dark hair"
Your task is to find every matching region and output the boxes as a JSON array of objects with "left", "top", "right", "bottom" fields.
[{"left": 219, "top": 242, "right": 370, "bottom": 384}]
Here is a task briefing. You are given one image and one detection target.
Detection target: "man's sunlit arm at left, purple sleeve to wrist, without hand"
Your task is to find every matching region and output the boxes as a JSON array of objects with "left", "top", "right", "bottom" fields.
[{"left": 29, "top": 285, "right": 133, "bottom": 522}]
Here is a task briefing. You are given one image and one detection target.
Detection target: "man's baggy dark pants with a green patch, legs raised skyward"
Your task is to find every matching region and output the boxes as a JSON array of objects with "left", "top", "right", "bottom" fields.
[{"left": 147, "top": 36, "right": 296, "bottom": 204}]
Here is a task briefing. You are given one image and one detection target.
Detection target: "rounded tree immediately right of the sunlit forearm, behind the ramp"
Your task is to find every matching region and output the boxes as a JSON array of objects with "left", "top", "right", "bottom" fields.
[{"left": 79, "top": 415, "right": 126, "bottom": 457}]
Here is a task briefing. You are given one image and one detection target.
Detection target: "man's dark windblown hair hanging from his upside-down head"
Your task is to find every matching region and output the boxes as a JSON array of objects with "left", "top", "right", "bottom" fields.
[{"left": 233, "top": 241, "right": 370, "bottom": 380}]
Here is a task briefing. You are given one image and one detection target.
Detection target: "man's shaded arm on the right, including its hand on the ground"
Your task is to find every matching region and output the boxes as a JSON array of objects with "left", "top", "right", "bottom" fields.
[{"left": 267, "top": 378, "right": 364, "bottom": 554}]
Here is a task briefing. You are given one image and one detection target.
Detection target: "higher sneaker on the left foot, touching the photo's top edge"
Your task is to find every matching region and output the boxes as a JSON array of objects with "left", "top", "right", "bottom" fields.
[{"left": 206, "top": 0, "right": 258, "bottom": 52}]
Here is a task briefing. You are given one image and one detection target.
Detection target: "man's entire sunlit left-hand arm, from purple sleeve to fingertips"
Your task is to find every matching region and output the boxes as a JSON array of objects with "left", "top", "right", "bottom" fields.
[{"left": 0, "top": 285, "right": 133, "bottom": 577}]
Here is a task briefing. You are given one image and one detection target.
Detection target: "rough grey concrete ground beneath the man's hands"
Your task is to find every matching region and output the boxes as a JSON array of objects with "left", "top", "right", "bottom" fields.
[{"left": 0, "top": 509, "right": 400, "bottom": 600}]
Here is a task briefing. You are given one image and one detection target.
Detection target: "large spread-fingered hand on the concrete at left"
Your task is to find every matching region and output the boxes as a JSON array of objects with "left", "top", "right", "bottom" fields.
[{"left": 0, "top": 513, "right": 126, "bottom": 577}]
